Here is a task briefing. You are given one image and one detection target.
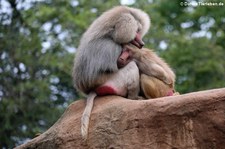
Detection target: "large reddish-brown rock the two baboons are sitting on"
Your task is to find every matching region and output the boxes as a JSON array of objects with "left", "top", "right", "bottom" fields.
[{"left": 17, "top": 88, "right": 225, "bottom": 149}]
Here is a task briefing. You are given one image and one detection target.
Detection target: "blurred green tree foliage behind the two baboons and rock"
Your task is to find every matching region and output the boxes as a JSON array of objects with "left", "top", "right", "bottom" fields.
[{"left": 0, "top": 0, "right": 225, "bottom": 149}]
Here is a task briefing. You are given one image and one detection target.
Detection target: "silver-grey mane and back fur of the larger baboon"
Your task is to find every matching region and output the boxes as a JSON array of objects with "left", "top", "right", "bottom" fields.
[{"left": 73, "top": 6, "right": 150, "bottom": 93}]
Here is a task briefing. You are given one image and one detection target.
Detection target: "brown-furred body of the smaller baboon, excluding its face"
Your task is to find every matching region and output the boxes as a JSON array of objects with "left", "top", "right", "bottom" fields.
[{"left": 125, "top": 45, "right": 175, "bottom": 98}]
